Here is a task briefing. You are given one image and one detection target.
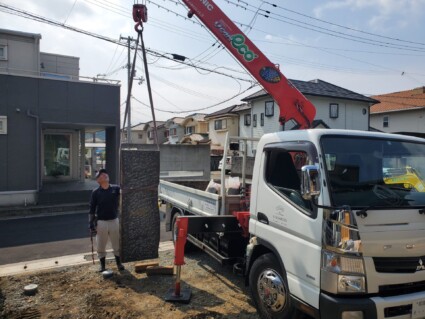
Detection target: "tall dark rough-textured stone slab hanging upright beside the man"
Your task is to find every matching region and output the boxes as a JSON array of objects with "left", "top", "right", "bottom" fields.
[{"left": 120, "top": 150, "right": 160, "bottom": 262}]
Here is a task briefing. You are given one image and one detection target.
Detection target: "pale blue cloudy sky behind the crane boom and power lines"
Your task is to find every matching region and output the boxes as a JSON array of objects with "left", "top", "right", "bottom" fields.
[{"left": 0, "top": 0, "right": 425, "bottom": 124}]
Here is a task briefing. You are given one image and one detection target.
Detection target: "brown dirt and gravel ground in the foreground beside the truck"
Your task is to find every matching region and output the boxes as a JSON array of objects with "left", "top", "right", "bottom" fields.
[{"left": 0, "top": 251, "right": 258, "bottom": 319}]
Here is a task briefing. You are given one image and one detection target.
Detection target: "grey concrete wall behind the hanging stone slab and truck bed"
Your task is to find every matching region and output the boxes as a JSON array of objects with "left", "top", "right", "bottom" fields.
[{"left": 122, "top": 144, "right": 211, "bottom": 181}]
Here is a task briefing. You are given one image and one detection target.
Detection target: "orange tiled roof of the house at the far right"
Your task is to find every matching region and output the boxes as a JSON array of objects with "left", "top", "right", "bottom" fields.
[{"left": 370, "top": 86, "right": 425, "bottom": 114}]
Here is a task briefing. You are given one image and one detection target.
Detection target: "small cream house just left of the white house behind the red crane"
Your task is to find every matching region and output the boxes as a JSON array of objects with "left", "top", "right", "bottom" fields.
[{"left": 205, "top": 103, "right": 247, "bottom": 154}]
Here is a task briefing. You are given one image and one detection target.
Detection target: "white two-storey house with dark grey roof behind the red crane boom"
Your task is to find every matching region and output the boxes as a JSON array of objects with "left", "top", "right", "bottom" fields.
[{"left": 240, "top": 79, "right": 378, "bottom": 156}]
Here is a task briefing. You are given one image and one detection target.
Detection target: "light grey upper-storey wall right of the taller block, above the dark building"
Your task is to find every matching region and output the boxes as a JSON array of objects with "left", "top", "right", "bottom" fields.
[{"left": 40, "top": 52, "right": 80, "bottom": 79}]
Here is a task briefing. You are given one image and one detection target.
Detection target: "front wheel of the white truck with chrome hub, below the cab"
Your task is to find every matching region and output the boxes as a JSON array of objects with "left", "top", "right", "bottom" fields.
[{"left": 249, "top": 253, "right": 294, "bottom": 319}]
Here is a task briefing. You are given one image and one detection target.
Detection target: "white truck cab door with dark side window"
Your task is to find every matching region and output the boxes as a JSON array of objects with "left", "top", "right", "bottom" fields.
[{"left": 255, "top": 142, "right": 322, "bottom": 308}]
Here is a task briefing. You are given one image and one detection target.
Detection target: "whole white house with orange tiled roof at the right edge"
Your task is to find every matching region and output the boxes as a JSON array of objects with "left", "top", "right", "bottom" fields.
[{"left": 370, "top": 86, "right": 425, "bottom": 137}]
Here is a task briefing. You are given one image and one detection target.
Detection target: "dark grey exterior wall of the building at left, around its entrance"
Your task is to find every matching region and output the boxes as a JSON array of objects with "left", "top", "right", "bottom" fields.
[{"left": 0, "top": 74, "right": 120, "bottom": 201}]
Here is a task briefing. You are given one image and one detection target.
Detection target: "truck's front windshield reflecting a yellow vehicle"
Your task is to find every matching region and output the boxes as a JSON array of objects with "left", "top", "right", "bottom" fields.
[{"left": 321, "top": 136, "right": 425, "bottom": 208}]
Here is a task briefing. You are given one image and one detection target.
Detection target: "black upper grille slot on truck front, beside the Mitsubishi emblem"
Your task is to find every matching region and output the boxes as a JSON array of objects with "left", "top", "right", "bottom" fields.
[{"left": 373, "top": 256, "right": 425, "bottom": 274}]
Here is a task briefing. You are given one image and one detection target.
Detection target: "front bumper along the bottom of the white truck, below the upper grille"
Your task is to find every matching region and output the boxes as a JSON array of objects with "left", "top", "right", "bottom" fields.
[{"left": 319, "top": 291, "right": 425, "bottom": 319}]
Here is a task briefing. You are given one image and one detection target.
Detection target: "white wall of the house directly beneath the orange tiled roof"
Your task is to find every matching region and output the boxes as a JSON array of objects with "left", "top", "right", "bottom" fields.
[{"left": 370, "top": 109, "right": 425, "bottom": 134}]
